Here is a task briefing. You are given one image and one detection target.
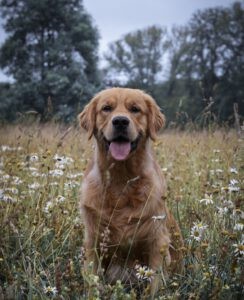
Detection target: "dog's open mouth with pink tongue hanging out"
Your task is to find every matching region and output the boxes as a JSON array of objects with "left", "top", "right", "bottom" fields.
[{"left": 105, "top": 136, "right": 140, "bottom": 160}]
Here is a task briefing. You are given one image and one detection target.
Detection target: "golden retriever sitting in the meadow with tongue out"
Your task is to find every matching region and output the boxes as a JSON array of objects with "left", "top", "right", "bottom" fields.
[{"left": 79, "top": 88, "right": 183, "bottom": 293}]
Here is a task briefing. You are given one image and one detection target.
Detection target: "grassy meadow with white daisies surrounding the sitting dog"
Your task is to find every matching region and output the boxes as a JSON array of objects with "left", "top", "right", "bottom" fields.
[{"left": 0, "top": 124, "right": 244, "bottom": 299}]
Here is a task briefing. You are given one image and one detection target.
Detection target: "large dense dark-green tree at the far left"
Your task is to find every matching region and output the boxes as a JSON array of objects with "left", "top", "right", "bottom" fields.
[{"left": 0, "top": 0, "right": 99, "bottom": 119}]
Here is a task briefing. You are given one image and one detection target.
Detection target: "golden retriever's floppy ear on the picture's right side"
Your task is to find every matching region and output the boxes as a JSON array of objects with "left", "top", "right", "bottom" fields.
[{"left": 145, "top": 94, "right": 165, "bottom": 141}]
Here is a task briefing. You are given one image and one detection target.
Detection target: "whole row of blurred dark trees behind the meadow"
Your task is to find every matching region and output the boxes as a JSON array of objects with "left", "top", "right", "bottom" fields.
[{"left": 0, "top": 0, "right": 244, "bottom": 127}]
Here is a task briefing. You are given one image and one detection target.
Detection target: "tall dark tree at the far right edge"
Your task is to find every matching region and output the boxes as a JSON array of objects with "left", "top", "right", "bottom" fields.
[{"left": 169, "top": 2, "right": 244, "bottom": 120}]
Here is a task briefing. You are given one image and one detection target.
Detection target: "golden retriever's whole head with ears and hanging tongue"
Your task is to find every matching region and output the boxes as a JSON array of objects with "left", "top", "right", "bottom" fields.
[{"left": 79, "top": 88, "right": 164, "bottom": 160}]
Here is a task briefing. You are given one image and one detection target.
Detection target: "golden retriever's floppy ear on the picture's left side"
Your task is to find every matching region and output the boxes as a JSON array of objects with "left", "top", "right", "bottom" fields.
[{"left": 78, "top": 97, "right": 97, "bottom": 140}]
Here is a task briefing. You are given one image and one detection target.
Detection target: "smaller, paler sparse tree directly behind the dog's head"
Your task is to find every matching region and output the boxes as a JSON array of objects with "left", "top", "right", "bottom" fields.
[{"left": 105, "top": 26, "right": 167, "bottom": 93}]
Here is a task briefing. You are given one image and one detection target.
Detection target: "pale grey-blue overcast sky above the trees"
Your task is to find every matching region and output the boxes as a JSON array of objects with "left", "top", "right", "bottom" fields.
[{"left": 0, "top": 0, "right": 234, "bottom": 81}]
